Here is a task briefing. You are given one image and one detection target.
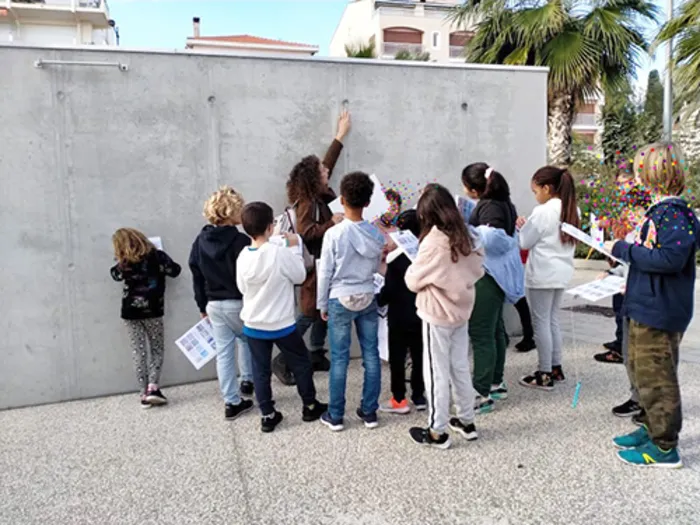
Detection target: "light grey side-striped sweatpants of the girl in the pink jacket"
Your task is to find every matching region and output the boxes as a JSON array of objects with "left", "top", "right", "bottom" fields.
[{"left": 423, "top": 321, "right": 475, "bottom": 434}]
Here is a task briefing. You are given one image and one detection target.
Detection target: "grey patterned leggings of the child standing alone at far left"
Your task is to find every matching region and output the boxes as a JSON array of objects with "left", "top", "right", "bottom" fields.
[{"left": 124, "top": 317, "right": 165, "bottom": 394}]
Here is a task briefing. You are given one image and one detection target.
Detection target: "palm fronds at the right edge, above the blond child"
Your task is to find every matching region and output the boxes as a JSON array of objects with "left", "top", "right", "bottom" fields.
[{"left": 656, "top": 0, "right": 700, "bottom": 125}]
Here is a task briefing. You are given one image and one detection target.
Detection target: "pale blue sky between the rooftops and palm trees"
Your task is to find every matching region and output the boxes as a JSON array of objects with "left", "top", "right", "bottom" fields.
[{"left": 108, "top": 0, "right": 665, "bottom": 88}]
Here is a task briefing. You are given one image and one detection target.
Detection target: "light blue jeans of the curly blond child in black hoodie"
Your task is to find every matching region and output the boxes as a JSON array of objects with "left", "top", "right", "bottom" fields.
[{"left": 207, "top": 299, "right": 253, "bottom": 405}]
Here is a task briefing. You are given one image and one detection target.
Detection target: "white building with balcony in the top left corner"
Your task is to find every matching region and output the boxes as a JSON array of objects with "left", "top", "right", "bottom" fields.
[{"left": 0, "top": 0, "right": 119, "bottom": 46}]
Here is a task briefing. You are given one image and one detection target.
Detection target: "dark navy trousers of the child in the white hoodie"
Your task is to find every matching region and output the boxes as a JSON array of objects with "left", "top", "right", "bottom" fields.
[{"left": 248, "top": 330, "right": 316, "bottom": 416}]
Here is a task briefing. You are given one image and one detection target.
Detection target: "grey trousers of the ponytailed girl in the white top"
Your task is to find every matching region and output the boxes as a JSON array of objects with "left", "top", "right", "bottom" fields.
[{"left": 525, "top": 288, "right": 564, "bottom": 373}]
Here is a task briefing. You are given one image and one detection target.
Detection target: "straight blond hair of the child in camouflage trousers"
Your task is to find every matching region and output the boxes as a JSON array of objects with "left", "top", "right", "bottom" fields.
[{"left": 634, "top": 142, "right": 687, "bottom": 195}]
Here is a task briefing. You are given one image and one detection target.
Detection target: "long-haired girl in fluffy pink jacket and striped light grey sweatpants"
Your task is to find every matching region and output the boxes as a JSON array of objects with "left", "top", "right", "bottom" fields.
[{"left": 406, "top": 184, "right": 484, "bottom": 449}]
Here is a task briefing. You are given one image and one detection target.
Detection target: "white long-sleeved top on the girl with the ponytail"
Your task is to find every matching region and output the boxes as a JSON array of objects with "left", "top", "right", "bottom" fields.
[{"left": 520, "top": 198, "right": 575, "bottom": 288}]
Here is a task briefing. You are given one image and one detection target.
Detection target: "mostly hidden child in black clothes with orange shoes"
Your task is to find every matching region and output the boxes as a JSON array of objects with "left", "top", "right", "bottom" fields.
[{"left": 377, "top": 210, "right": 427, "bottom": 414}]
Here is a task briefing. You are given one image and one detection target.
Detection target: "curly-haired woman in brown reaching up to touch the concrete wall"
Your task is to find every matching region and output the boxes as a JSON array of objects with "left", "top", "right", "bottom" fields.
[{"left": 272, "top": 111, "right": 350, "bottom": 385}]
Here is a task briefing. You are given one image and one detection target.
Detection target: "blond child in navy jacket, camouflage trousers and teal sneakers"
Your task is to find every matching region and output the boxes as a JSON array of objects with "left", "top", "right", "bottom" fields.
[{"left": 606, "top": 144, "right": 700, "bottom": 468}]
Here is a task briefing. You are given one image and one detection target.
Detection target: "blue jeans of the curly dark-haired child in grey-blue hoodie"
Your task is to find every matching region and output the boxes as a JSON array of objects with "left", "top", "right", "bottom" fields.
[{"left": 328, "top": 299, "right": 382, "bottom": 421}]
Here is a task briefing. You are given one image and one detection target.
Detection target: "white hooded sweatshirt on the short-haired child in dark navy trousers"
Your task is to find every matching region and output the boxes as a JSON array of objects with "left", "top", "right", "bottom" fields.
[{"left": 236, "top": 242, "right": 306, "bottom": 332}]
